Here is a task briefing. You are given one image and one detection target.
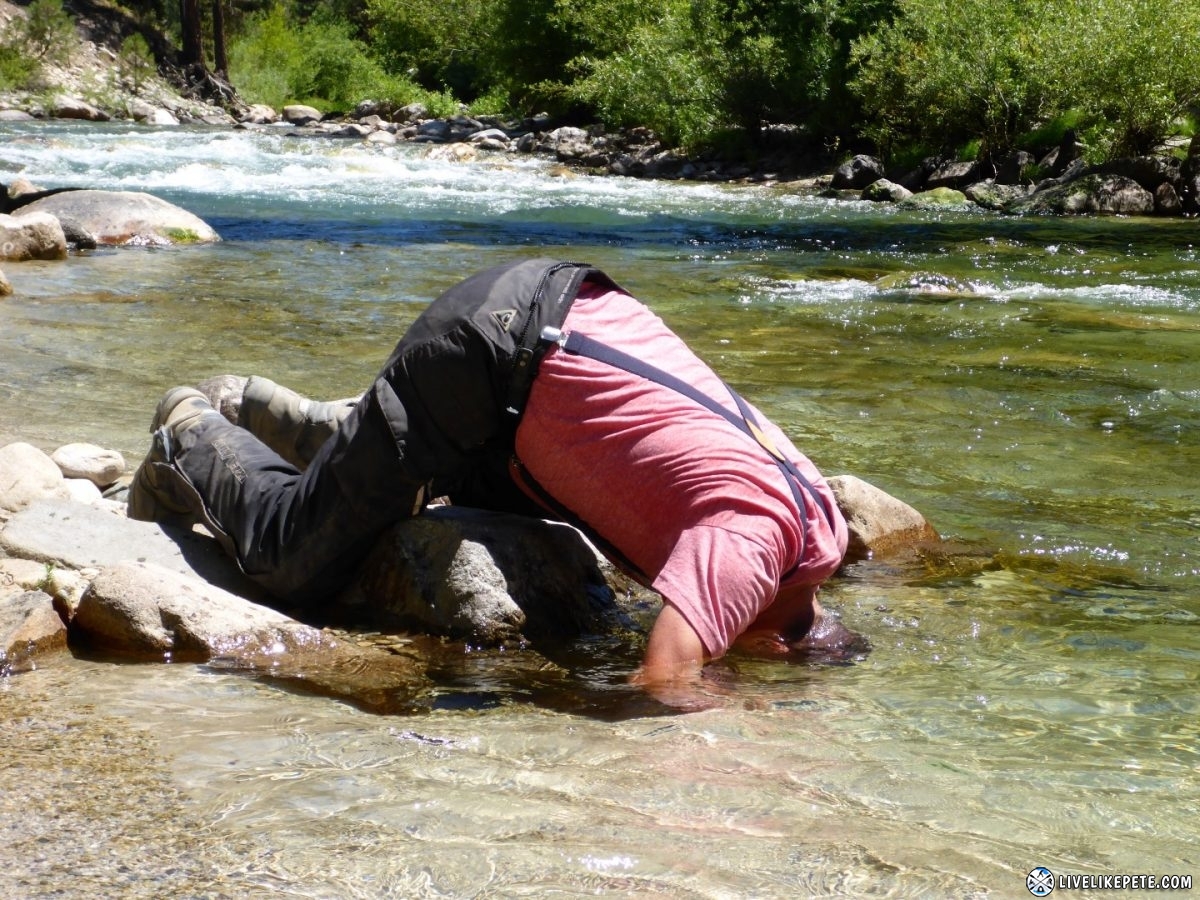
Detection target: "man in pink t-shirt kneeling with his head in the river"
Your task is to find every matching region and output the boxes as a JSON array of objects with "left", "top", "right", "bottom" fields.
[{"left": 130, "top": 259, "right": 848, "bottom": 688}]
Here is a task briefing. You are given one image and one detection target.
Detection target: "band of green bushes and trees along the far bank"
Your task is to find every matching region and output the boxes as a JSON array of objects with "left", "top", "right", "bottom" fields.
[{"left": 0, "top": 0, "right": 1200, "bottom": 168}]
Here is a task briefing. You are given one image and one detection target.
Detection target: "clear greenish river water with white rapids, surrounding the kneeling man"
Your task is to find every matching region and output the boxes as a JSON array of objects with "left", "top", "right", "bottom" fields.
[{"left": 0, "top": 124, "right": 1200, "bottom": 896}]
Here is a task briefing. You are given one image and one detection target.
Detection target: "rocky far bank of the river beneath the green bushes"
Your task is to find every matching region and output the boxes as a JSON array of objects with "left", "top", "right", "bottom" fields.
[{"left": 0, "top": 0, "right": 1200, "bottom": 216}]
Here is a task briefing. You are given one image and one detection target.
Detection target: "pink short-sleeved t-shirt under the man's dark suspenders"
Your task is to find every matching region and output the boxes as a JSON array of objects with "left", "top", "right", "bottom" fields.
[{"left": 516, "top": 284, "right": 846, "bottom": 658}]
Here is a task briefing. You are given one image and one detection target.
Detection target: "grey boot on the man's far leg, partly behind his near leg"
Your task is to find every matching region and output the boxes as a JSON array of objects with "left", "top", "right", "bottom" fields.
[{"left": 238, "top": 376, "right": 359, "bottom": 469}]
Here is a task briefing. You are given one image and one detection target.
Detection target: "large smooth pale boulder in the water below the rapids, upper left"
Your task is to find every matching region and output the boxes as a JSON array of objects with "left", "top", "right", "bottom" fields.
[{"left": 22, "top": 191, "right": 221, "bottom": 246}]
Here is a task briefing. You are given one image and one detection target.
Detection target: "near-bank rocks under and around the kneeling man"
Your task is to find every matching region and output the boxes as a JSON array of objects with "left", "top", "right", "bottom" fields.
[{"left": 0, "top": 434, "right": 955, "bottom": 713}]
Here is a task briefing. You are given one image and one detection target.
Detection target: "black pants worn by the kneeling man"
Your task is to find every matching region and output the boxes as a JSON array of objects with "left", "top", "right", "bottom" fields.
[{"left": 165, "top": 259, "right": 604, "bottom": 605}]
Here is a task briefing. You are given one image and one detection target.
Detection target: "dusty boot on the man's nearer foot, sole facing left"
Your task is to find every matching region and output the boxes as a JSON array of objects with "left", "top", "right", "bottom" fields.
[{"left": 128, "top": 388, "right": 220, "bottom": 524}]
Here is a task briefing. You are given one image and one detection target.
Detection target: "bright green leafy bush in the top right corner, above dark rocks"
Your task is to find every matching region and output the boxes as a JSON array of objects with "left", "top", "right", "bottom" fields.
[{"left": 853, "top": 0, "right": 1200, "bottom": 161}]
